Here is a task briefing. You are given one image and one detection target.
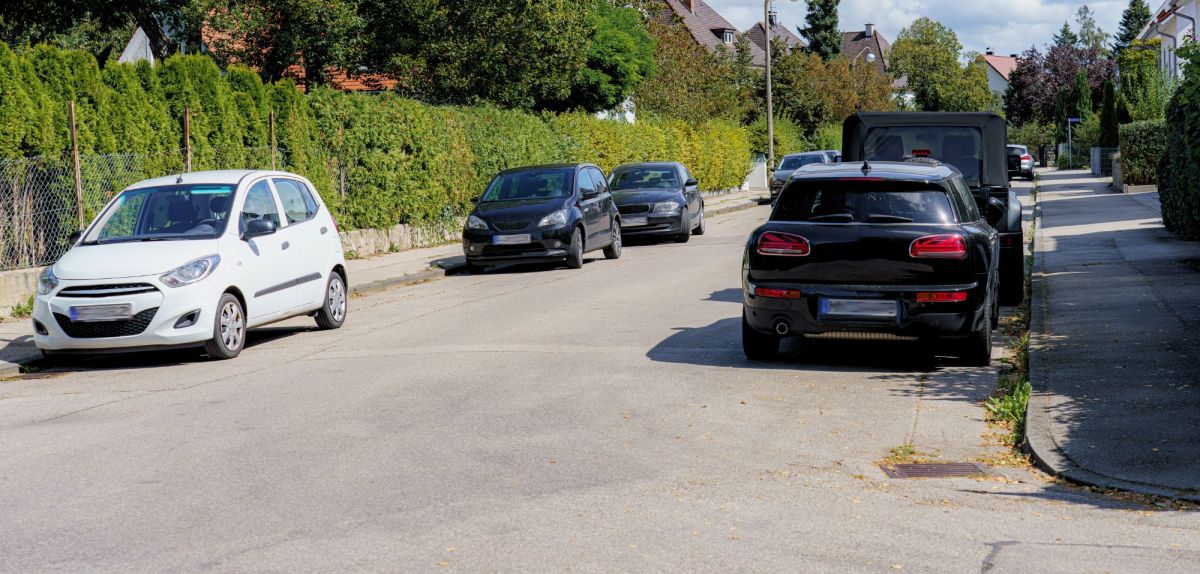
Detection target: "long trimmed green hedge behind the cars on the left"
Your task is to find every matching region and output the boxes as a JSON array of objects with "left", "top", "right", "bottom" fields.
[{"left": 0, "top": 44, "right": 750, "bottom": 228}]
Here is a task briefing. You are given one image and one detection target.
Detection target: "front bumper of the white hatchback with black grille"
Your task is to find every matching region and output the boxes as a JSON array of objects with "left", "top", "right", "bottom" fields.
[{"left": 32, "top": 276, "right": 222, "bottom": 352}]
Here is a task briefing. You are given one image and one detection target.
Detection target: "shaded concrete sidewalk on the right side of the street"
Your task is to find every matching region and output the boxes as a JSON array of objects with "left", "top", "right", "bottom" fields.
[{"left": 1026, "top": 171, "right": 1200, "bottom": 498}]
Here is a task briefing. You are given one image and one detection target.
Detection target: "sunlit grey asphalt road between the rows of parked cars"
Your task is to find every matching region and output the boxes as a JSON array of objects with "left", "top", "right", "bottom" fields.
[{"left": 0, "top": 194, "right": 1200, "bottom": 573}]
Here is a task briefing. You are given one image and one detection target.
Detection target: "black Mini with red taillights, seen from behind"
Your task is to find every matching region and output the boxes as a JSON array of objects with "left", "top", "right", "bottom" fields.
[{"left": 742, "top": 160, "right": 1000, "bottom": 365}]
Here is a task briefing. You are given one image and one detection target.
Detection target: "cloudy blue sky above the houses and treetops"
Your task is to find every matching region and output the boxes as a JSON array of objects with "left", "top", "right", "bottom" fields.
[{"left": 706, "top": 0, "right": 1137, "bottom": 55}]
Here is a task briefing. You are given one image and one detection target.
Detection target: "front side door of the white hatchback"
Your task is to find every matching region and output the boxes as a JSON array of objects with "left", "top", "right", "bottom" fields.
[{"left": 235, "top": 178, "right": 295, "bottom": 322}]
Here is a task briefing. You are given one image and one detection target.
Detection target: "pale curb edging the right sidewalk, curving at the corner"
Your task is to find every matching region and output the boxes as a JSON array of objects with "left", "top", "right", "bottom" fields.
[{"left": 1024, "top": 196, "right": 1200, "bottom": 502}]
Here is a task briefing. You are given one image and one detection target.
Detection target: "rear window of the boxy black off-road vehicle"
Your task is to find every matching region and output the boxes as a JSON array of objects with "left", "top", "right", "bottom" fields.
[{"left": 863, "top": 126, "right": 983, "bottom": 185}]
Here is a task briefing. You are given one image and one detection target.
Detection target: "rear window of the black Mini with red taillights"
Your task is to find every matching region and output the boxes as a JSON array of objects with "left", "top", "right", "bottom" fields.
[{"left": 770, "top": 180, "right": 954, "bottom": 223}]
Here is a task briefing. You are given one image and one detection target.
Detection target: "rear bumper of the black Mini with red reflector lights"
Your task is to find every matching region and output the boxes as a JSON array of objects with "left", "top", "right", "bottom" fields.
[{"left": 743, "top": 283, "right": 988, "bottom": 339}]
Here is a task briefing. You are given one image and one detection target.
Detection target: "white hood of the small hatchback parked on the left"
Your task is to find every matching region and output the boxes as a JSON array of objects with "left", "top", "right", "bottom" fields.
[{"left": 54, "top": 239, "right": 220, "bottom": 280}]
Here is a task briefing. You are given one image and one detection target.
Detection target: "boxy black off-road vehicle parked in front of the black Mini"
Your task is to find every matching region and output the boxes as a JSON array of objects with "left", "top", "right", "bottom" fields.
[{"left": 841, "top": 112, "right": 1025, "bottom": 305}]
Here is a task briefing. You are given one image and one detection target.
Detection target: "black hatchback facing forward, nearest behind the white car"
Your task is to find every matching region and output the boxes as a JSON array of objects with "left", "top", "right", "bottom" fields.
[{"left": 462, "top": 163, "right": 620, "bottom": 271}]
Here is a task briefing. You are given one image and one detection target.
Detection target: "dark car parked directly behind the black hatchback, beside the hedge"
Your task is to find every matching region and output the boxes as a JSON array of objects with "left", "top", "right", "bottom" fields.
[{"left": 608, "top": 163, "right": 704, "bottom": 243}]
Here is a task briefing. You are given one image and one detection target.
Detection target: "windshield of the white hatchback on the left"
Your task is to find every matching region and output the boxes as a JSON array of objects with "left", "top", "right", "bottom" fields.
[{"left": 83, "top": 184, "right": 234, "bottom": 245}]
